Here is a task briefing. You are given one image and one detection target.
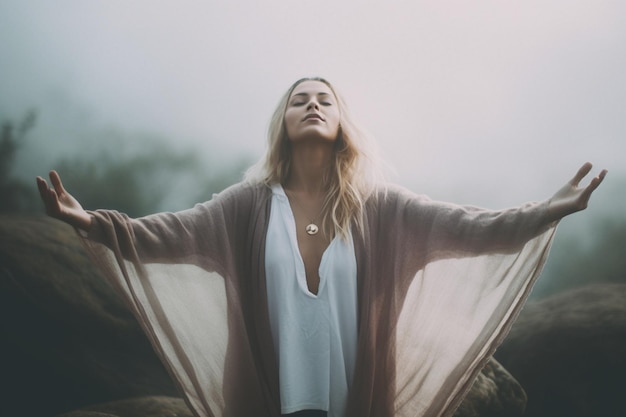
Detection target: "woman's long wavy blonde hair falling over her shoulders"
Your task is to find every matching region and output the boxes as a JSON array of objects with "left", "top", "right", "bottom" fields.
[{"left": 245, "top": 77, "right": 382, "bottom": 238}]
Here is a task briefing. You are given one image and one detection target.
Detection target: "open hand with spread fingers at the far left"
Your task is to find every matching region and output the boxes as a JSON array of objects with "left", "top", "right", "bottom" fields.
[{"left": 37, "top": 171, "right": 91, "bottom": 230}]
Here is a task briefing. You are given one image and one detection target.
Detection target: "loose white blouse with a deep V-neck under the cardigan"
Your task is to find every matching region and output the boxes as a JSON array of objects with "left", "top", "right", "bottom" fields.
[{"left": 265, "top": 184, "right": 357, "bottom": 417}]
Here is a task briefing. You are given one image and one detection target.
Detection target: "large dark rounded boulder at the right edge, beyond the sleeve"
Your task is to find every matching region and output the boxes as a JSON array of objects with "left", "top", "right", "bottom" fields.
[{"left": 495, "top": 284, "right": 626, "bottom": 417}]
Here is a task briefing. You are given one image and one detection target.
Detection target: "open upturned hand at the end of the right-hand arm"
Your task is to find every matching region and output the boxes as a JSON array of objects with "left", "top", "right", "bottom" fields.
[{"left": 548, "top": 162, "right": 607, "bottom": 220}]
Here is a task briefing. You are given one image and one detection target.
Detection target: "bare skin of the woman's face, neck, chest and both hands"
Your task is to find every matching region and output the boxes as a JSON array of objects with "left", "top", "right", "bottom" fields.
[{"left": 37, "top": 81, "right": 607, "bottom": 294}]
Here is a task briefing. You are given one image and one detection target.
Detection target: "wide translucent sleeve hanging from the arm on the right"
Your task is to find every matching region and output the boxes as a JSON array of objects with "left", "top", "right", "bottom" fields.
[{"left": 396, "top": 187, "right": 556, "bottom": 416}]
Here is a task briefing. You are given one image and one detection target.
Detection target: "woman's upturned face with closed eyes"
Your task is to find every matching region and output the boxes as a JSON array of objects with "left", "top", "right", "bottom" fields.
[{"left": 285, "top": 81, "right": 340, "bottom": 142}]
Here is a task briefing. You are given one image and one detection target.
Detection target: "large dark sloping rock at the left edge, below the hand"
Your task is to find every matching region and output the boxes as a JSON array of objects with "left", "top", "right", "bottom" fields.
[{"left": 0, "top": 216, "right": 177, "bottom": 416}]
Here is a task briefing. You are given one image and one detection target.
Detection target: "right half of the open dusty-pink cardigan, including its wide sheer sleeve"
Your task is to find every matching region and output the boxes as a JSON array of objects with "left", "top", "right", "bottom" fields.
[{"left": 348, "top": 185, "right": 556, "bottom": 417}]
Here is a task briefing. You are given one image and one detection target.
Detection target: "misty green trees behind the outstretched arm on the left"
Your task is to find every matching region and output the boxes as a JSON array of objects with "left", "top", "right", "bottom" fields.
[{"left": 0, "top": 112, "right": 250, "bottom": 217}]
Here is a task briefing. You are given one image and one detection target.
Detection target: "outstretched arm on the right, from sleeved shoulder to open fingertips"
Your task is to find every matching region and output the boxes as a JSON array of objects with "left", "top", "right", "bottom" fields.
[{"left": 383, "top": 163, "right": 606, "bottom": 260}]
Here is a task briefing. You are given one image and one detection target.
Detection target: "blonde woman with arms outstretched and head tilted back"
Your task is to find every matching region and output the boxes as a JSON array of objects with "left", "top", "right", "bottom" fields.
[{"left": 37, "top": 78, "right": 606, "bottom": 417}]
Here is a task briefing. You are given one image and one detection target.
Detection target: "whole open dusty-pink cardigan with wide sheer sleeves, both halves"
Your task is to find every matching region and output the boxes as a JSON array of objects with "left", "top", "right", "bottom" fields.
[{"left": 83, "top": 184, "right": 556, "bottom": 417}]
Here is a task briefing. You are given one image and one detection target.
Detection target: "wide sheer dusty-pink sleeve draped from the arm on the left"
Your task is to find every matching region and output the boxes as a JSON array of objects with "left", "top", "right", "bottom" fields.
[{"left": 76, "top": 185, "right": 268, "bottom": 416}]
